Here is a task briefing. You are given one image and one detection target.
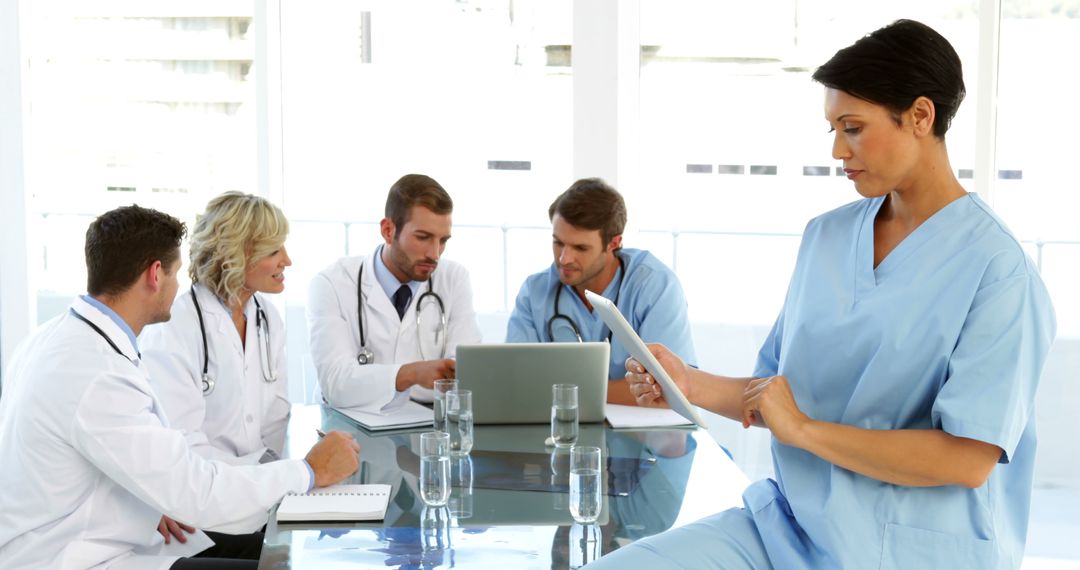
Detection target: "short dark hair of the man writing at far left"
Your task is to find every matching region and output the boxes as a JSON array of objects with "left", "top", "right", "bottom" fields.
[{"left": 85, "top": 205, "right": 187, "bottom": 296}]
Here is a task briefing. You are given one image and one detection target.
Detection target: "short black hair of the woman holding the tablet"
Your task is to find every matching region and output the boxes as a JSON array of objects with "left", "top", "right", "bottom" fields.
[{"left": 813, "top": 19, "right": 967, "bottom": 138}]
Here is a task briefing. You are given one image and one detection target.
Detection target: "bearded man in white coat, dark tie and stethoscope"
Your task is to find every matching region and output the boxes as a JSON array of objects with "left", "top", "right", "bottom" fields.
[{"left": 308, "top": 174, "right": 481, "bottom": 412}]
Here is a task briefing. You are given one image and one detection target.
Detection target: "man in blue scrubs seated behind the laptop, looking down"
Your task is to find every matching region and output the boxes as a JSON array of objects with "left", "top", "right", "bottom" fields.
[{"left": 507, "top": 178, "right": 697, "bottom": 405}]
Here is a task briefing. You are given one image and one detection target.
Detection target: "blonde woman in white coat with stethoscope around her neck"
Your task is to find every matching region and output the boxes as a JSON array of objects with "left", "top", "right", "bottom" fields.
[{"left": 139, "top": 192, "right": 292, "bottom": 532}]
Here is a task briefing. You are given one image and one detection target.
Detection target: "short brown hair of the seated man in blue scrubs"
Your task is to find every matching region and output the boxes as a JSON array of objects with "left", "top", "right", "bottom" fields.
[{"left": 548, "top": 178, "right": 626, "bottom": 247}]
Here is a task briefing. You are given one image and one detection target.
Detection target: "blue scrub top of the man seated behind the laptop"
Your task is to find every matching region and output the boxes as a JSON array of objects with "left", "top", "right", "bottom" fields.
[{"left": 507, "top": 248, "right": 698, "bottom": 379}]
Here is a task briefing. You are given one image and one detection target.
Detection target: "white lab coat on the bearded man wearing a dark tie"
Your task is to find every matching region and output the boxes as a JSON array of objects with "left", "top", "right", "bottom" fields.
[{"left": 308, "top": 248, "right": 481, "bottom": 412}]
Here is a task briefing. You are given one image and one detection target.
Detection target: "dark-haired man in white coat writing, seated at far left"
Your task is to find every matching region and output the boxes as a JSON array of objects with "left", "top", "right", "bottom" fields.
[{"left": 0, "top": 206, "right": 359, "bottom": 570}]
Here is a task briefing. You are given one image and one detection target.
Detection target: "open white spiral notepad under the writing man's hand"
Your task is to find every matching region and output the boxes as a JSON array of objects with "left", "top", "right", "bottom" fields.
[{"left": 278, "top": 485, "right": 392, "bottom": 523}]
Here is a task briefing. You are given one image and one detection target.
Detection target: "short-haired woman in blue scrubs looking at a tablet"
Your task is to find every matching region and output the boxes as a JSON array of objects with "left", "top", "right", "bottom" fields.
[{"left": 596, "top": 21, "right": 1056, "bottom": 570}]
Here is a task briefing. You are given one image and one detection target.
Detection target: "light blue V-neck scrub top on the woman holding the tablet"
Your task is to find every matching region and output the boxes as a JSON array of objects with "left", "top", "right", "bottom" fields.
[{"left": 744, "top": 194, "right": 1056, "bottom": 568}]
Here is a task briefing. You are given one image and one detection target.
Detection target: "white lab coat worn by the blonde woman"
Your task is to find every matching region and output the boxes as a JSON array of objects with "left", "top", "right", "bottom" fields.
[{"left": 138, "top": 285, "right": 289, "bottom": 466}]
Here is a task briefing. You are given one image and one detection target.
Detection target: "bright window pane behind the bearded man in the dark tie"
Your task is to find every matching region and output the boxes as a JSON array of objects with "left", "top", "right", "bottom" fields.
[{"left": 281, "top": 0, "right": 572, "bottom": 401}]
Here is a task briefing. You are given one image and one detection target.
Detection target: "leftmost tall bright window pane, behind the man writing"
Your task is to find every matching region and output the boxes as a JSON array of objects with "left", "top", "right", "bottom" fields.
[{"left": 22, "top": 0, "right": 256, "bottom": 321}]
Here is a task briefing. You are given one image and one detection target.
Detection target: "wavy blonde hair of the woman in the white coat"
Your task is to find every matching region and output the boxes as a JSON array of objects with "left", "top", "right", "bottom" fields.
[{"left": 188, "top": 192, "right": 288, "bottom": 307}]
